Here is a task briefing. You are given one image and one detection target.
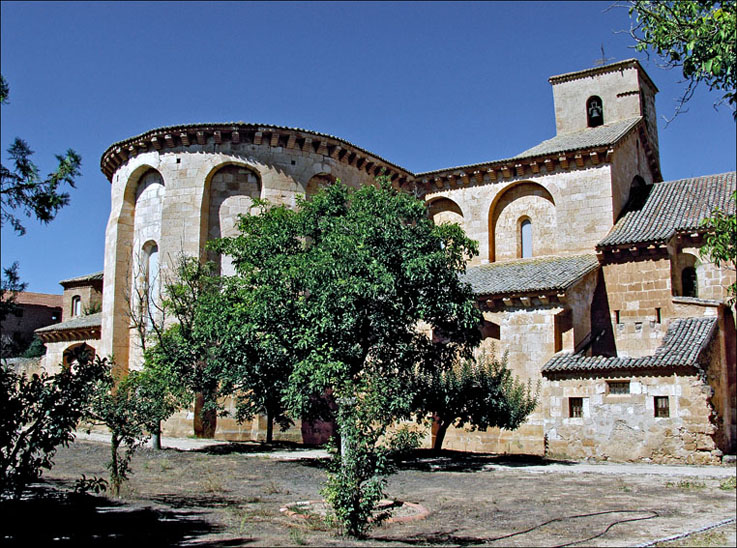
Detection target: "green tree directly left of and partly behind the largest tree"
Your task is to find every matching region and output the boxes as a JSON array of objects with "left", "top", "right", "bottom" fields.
[{"left": 209, "top": 200, "right": 306, "bottom": 443}]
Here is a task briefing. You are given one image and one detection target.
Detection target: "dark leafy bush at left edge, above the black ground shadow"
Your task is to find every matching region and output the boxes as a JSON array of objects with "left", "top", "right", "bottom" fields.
[{"left": 0, "top": 352, "right": 105, "bottom": 498}]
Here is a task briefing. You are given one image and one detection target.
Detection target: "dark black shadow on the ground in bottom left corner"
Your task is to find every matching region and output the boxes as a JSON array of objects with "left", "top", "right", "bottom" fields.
[{"left": 0, "top": 484, "right": 253, "bottom": 547}]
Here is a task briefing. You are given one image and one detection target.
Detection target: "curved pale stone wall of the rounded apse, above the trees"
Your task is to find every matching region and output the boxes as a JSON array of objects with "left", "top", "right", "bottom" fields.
[{"left": 101, "top": 137, "right": 388, "bottom": 368}]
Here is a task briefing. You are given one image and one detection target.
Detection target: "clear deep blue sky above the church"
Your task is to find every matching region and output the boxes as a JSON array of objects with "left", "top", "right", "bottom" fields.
[{"left": 0, "top": 2, "right": 735, "bottom": 293}]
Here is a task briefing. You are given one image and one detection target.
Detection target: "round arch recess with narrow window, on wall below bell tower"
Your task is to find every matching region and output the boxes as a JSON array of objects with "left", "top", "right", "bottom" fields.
[{"left": 489, "top": 181, "right": 557, "bottom": 262}]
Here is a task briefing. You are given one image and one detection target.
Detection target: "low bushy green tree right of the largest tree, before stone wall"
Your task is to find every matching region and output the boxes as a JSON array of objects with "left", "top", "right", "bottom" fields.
[{"left": 414, "top": 353, "right": 537, "bottom": 451}]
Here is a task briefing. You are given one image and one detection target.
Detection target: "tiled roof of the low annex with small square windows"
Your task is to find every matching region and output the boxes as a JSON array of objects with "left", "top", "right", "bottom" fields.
[{"left": 542, "top": 318, "right": 717, "bottom": 373}]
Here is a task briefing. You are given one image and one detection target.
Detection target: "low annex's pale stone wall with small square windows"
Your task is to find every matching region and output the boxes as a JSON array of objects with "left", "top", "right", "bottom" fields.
[{"left": 544, "top": 372, "right": 721, "bottom": 464}]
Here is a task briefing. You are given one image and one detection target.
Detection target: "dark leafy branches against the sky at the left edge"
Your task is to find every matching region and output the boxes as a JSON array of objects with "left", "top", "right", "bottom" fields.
[{"left": 0, "top": 76, "right": 82, "bottom": 234}]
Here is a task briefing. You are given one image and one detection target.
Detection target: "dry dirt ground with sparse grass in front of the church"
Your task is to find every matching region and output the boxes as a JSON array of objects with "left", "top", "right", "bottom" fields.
[{"left": 0, "top": 441, "right": 735, "bottom": 547}]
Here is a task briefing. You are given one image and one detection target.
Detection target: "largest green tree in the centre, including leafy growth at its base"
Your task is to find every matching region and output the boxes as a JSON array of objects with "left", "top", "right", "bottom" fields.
[{"left": 220, "top": 178, "right": 481, "bottom": 536}]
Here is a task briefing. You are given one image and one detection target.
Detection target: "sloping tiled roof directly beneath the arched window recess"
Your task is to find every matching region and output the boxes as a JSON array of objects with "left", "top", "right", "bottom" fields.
[{"left": 463, "top": 254, "right": 599, "bottom": 295}]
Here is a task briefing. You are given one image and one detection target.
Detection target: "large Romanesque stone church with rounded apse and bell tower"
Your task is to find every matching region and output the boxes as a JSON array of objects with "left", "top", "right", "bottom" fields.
[{"left": 45, "top": 60, "right": 737, "bottom": 463}]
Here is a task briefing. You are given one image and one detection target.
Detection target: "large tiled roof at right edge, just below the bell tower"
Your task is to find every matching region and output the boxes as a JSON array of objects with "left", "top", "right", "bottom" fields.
[{"left": 597, "top": 171, "right": 735, "bottom": 247}]
